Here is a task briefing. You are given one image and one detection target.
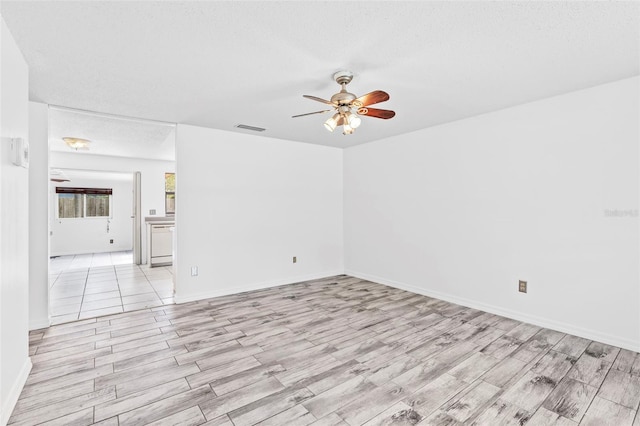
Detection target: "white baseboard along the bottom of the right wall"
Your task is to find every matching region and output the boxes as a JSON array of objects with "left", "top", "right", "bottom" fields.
[{"left": 345, "top": 270, "right": 640, "bottom": 352}]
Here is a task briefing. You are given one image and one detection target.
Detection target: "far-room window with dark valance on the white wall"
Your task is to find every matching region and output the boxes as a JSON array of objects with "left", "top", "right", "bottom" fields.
[{"left": 56, "top": 187, "right": 113, "bottom": 219}]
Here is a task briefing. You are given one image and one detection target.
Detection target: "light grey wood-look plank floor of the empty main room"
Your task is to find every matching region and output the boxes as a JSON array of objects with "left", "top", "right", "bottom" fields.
[{"left": 10, "top": 276, "right": 640, "bottom": 426}]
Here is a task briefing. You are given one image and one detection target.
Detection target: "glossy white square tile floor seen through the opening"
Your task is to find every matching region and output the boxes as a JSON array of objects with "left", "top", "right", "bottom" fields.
[{"left": 49, "top": 251, "right": 173, "bottom": 324}]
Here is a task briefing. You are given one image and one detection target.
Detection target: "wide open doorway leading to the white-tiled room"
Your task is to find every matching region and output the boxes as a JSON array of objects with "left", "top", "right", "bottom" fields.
[{"left": 49, "top": 107, "right": 175, "bottom": 324}]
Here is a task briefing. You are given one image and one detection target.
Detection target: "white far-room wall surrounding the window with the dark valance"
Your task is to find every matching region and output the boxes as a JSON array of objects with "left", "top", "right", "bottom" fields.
[{"left": 50, "top": 174, "right": 133, "bottom": 256}]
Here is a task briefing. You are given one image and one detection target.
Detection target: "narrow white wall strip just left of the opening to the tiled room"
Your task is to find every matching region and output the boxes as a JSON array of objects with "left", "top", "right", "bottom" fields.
[{"left": 29, "top": 102, "right": 49, "bottom": 330}]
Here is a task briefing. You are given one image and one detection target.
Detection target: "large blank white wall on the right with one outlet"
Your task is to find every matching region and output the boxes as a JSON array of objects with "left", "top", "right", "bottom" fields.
[{"left": 344, "top": 77, "right": 640, "bottom": 351}]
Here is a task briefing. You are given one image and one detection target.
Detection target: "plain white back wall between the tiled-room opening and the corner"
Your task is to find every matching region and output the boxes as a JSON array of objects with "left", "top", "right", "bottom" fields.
[{"left": 176, "top": 125, "right": 343, "bottom": 302}]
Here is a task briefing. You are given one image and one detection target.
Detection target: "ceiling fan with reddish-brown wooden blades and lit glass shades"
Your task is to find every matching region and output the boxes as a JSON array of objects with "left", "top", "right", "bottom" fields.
[{"left": 292, "top": 71, "right": 396, "bottom": 135}]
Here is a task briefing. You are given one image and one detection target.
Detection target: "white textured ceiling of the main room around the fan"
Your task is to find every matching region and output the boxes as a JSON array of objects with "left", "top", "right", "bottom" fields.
[{"left": 1, "top": 0, "right": 640, "bottom": 147}]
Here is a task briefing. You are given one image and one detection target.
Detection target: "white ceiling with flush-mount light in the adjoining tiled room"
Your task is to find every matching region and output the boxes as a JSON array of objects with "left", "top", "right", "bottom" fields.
[{"left": 49, "top": 108, "right": 175, "bottom": 161}]
